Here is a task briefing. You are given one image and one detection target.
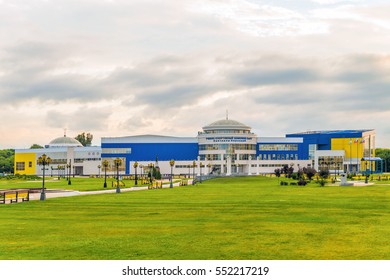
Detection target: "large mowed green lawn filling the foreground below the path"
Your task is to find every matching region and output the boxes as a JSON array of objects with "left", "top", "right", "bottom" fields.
[{"left": 0, "top": 177, "right": 390, "bottom": 260}]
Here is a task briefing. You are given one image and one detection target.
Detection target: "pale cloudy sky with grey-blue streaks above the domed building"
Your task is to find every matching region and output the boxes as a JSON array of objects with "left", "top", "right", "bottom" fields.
[{"left": 0, "top": 0, "right": 390, "bottom": 149}]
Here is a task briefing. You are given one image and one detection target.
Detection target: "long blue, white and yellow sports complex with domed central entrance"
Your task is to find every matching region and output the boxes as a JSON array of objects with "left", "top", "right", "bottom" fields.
[{"left": 15, "top": 118, "right": 382, "bottom": 176}]
